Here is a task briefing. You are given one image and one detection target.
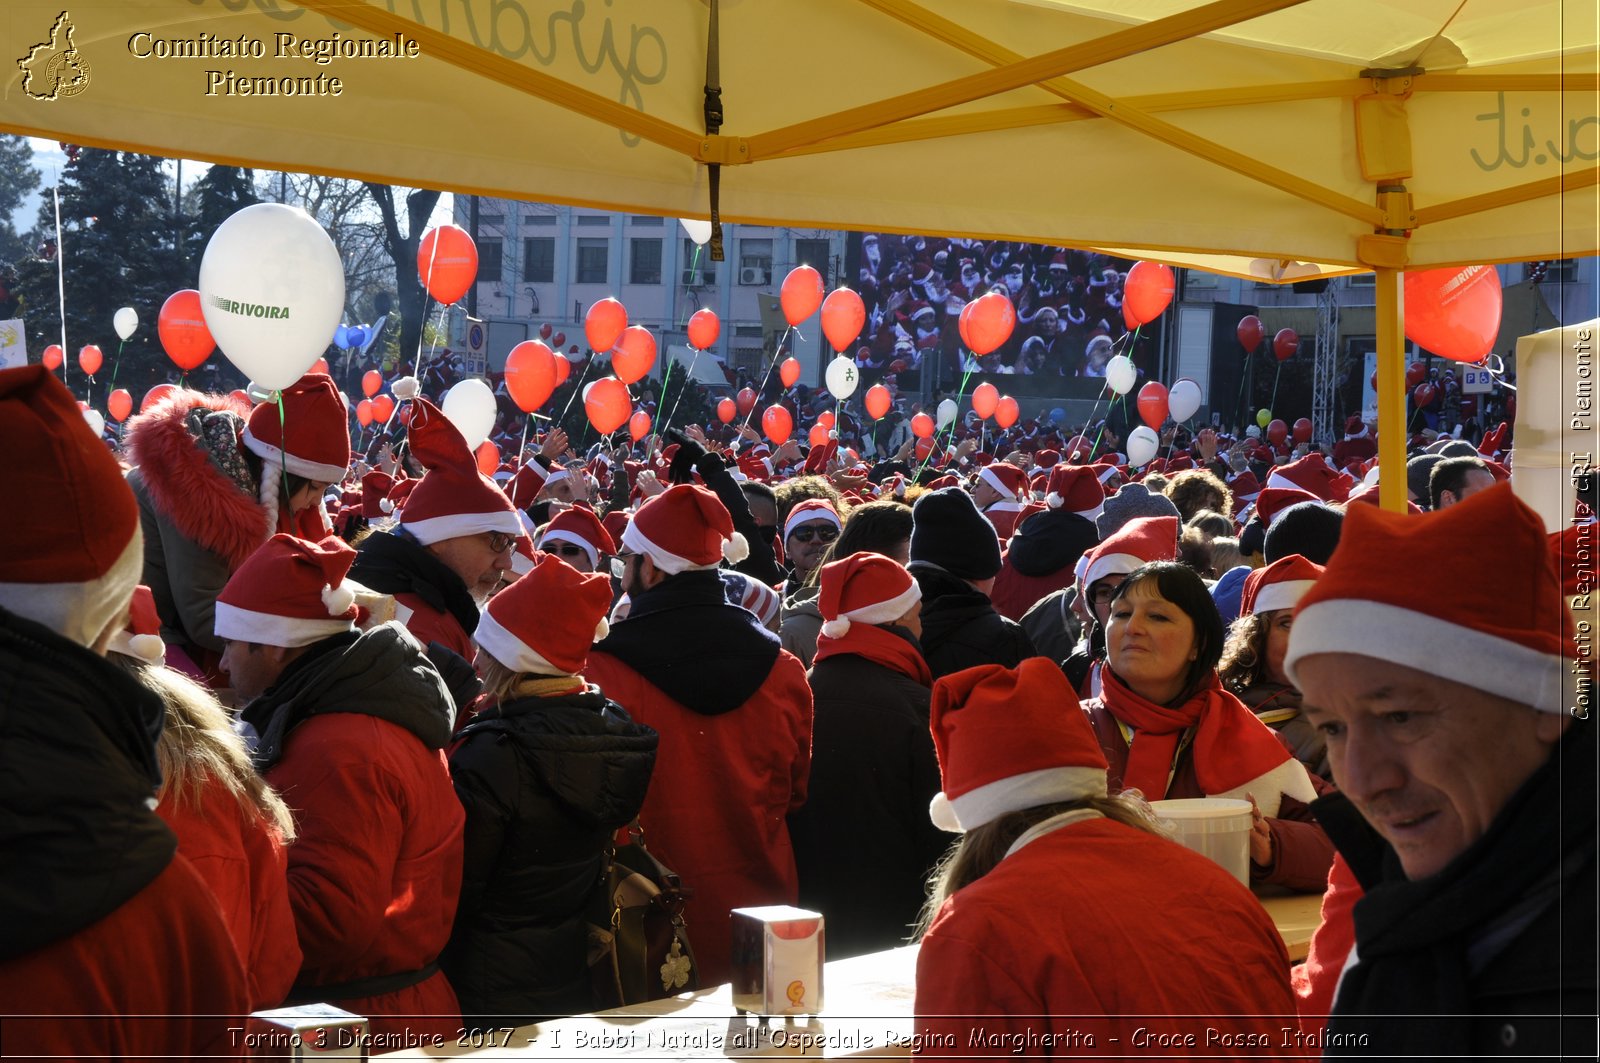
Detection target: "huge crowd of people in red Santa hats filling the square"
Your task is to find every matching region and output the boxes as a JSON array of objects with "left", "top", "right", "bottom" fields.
[{"left": 0, "top": 358, "right": 1600, "bottom": 1058}]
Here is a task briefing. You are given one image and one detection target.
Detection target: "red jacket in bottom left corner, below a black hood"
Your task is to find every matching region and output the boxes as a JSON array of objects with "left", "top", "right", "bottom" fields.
[{"left": 0, "top": 853, "right": 250, "bottom": 1060}]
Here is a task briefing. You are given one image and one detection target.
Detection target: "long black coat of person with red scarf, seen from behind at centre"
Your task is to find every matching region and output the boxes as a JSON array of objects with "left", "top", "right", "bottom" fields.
[{"left": 789, "top": 643, "right": 955, "bottom": 959}]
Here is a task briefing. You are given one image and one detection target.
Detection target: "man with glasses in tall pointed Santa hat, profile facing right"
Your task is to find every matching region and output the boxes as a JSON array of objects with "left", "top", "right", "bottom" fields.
[{"left": 350, "top": 399, "right": 523, "bottom": 661}]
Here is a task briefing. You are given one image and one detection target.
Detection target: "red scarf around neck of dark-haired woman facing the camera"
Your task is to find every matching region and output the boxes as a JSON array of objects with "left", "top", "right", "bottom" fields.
[{"left": 1101, "top": 668, "right": 1290, "bottom": 800}]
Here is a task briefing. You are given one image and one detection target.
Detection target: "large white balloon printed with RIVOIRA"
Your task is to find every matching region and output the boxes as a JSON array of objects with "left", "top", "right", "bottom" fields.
[{"left": 200, "top": 203, "right": 344, "bottom": 391}]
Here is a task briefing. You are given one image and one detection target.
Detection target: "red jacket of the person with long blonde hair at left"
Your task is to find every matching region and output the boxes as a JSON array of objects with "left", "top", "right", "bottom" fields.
[{"left": 155, "top": 776, "right": 301, "bottom": 1012}]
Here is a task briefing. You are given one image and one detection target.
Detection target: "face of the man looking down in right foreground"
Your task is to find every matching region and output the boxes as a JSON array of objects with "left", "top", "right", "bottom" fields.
[{"left": 1296, "top": 653, "right": 1565, "bottom": 880}]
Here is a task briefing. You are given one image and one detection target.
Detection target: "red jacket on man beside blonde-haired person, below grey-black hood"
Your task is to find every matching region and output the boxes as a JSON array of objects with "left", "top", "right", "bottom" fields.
[{"left": 267, "top": 712, "right": 466, "bottom": 1047}]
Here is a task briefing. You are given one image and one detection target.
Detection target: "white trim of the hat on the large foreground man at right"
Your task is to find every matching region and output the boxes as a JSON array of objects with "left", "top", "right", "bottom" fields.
[{"left": 1283, "top": 599, "right": 1574, "bottom": 712}]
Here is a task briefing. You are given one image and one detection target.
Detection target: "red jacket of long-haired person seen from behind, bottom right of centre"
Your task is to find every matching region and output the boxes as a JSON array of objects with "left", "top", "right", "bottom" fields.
[{"left": 915, "top": 813, "right": 1294, "bottom": 1058}]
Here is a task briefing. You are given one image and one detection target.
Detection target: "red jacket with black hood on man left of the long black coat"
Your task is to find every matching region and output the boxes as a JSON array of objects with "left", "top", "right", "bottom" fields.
[{"left": 584, "top": 650, "right": 811, "bottom": 986}]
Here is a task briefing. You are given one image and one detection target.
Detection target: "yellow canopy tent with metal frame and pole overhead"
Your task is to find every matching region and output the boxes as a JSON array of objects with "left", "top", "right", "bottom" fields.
[{"left": 0, "top": 0, "right": 1600, "bottom": 507}]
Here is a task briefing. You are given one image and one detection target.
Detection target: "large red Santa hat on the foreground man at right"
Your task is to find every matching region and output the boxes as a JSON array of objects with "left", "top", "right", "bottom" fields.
[{"left": 1283, "top": 483, "right": 1576, "bottom": 712}]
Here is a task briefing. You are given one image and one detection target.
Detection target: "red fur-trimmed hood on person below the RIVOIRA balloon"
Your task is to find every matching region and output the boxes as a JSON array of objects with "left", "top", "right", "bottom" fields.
[{"left": 128, "top": 391, "right": 270, "bottom": 568}]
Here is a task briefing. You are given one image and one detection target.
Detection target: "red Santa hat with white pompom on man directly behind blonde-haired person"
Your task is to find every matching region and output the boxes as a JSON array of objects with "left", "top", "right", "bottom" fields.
[{"left": 216, "top": 533, "right": 360, "bottom": 648}]
